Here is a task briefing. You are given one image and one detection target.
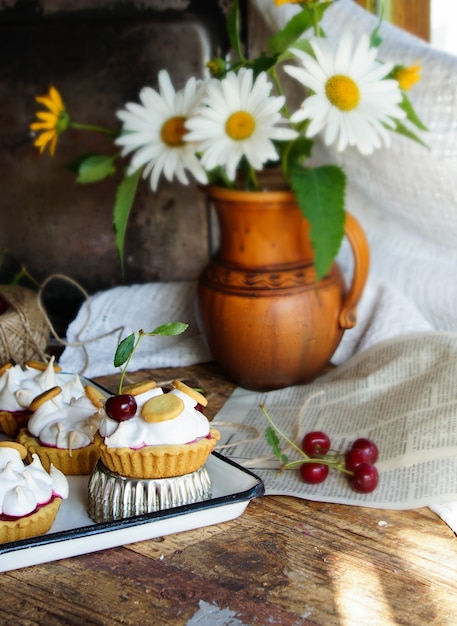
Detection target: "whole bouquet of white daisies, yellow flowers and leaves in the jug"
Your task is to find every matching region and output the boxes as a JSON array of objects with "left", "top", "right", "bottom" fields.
[{"left": 31, "top": 0, "right": 426, "bottom": 278}]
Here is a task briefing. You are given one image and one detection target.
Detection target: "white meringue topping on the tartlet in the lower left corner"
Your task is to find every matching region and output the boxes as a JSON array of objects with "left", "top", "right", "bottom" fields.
[{"left": 0, "top": 447, "right": 68, "bottom": 517}]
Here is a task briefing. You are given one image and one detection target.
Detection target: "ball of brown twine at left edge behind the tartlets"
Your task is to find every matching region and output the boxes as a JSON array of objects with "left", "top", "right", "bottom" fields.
[{"left": 0, "top": 285, "right": 49, "bottom": 364}]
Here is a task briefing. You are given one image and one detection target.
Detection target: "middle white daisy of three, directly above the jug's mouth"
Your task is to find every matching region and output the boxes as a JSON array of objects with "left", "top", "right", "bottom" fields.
[{"left": 186, "top": 68, "right": 297, "bottom": 180}]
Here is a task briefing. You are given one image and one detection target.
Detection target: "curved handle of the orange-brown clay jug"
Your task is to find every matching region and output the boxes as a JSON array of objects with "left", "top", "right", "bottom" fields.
[{"left": 338, "top": 213, "right": 370, "bottom": 329}]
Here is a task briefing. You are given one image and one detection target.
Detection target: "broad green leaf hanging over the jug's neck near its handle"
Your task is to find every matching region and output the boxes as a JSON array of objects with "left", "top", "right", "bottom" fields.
[{"left": 291, "top": 165, "right": 346, "bottom": 280}]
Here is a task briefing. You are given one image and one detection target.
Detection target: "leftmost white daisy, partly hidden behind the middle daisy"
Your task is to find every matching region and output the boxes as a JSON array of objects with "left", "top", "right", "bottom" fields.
[{"left": 116, "top": 70, "right": 207, "bottom": 191}]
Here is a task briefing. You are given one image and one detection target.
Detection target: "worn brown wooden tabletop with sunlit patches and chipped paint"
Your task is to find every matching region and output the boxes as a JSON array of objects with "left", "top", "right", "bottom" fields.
[{"left": 0, "top": 364, "right": 457, "bottom": 626}]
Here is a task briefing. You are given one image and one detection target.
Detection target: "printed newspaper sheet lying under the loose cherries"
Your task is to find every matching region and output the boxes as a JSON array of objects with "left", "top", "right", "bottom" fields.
[{"left": 214, "top": 332, "right": 457, "bottom": 509}]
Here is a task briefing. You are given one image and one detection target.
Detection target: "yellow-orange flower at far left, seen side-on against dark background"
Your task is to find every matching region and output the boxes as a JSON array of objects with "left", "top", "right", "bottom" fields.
[{"left": 30, "top": 85, "right": 70, "bottom": 156}]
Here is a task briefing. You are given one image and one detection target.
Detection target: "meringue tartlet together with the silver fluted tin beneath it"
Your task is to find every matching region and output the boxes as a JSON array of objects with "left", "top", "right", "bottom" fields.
[{"left": 89, "top": 381, "right": 220, "bottom": 521}]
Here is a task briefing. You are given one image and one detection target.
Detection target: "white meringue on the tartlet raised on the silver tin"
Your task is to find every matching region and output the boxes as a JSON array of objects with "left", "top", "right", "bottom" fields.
[{"left": 99, "top": 387, "right": 210, "bottom": 449}]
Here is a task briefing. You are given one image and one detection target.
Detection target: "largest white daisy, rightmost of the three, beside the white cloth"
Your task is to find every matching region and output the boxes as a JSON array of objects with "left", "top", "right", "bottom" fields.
[{"left": 284, "top": 32, "right": 406, "bottom": 154}]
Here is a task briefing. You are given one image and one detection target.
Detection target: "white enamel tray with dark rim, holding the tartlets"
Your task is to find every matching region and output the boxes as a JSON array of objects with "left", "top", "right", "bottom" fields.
[{"left": 0, "top": 452, "right": 264, "bottom": 572}]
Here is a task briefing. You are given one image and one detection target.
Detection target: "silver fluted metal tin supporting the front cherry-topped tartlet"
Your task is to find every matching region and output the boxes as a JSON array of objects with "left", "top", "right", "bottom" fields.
[{"left": 88, "top": 460, "right": 212, "bottom": 523}]
